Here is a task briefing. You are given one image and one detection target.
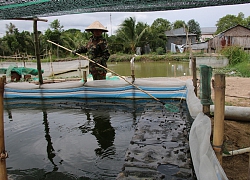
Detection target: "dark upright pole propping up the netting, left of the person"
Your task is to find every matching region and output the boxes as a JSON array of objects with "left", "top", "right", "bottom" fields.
[{"left": 33, "top": 19, "right": 43, "bottom": 84}]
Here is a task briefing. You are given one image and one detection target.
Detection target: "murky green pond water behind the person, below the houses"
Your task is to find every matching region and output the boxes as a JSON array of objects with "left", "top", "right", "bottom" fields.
[{"left": 55, "top": 61, "right": 192, "bottom": 78}]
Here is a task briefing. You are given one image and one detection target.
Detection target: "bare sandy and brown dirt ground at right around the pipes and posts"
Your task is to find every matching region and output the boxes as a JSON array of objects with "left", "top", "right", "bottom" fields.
[{"left": 180, "top": 77, "right": 250, "bottom": 180}]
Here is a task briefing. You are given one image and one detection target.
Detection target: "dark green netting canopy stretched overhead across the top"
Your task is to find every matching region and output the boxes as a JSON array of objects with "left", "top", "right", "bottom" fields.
[{"left": 0, "top": 0, "right": 250, "bottom": 20}]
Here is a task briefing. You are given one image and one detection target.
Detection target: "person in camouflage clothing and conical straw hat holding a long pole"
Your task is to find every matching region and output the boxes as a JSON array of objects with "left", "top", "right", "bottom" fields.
[{"left": 74, "top": 21, "right": 110, "bottom": 80}]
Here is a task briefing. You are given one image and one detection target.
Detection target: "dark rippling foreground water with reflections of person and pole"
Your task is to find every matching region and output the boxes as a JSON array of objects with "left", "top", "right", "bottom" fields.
[{"left": 4, "top": 99, "right": 159, "bottom": 180}]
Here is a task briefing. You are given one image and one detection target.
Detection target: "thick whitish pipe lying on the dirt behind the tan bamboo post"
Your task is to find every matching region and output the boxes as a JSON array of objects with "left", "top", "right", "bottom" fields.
[{"left": 210, "top": 105, "right": 250, "bottom": 121}]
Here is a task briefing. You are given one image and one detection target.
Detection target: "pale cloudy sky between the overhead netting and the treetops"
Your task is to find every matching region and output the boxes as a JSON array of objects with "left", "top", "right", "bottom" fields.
[{"left": 0, "top": 3, "right": 250, "bottom": 37}]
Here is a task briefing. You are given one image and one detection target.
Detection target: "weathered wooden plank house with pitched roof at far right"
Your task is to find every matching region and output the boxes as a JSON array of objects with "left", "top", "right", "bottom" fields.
[{"left": 208, "top": 25, "right": 250, "bottom": 52}]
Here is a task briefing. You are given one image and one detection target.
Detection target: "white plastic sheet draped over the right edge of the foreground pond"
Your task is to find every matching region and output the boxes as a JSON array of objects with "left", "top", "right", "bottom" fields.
[{"left": 186, "top": 79, "right": 228, "bottom": 180}]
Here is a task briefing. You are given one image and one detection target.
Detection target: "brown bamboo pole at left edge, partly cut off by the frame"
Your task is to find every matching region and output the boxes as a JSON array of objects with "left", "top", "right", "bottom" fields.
[{"left": 0, "top": 77, "right": 7, "bottom": 180}]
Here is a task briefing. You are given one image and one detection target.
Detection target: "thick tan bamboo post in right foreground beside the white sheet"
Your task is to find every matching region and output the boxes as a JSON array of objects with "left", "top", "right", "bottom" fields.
[{"left": 213, "top": 74, "right": 225, "bottom": 165}]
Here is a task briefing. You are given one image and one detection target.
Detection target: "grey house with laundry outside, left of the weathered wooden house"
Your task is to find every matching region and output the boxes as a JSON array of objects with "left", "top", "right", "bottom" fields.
[{"left": 165, "top": 28, "right": 196, "bottom": 52}]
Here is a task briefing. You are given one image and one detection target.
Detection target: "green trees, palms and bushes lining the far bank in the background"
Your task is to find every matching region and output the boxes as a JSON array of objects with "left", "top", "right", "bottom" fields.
[{"left": 0, "top": 13, "right": 250, "bottom": 66}]
